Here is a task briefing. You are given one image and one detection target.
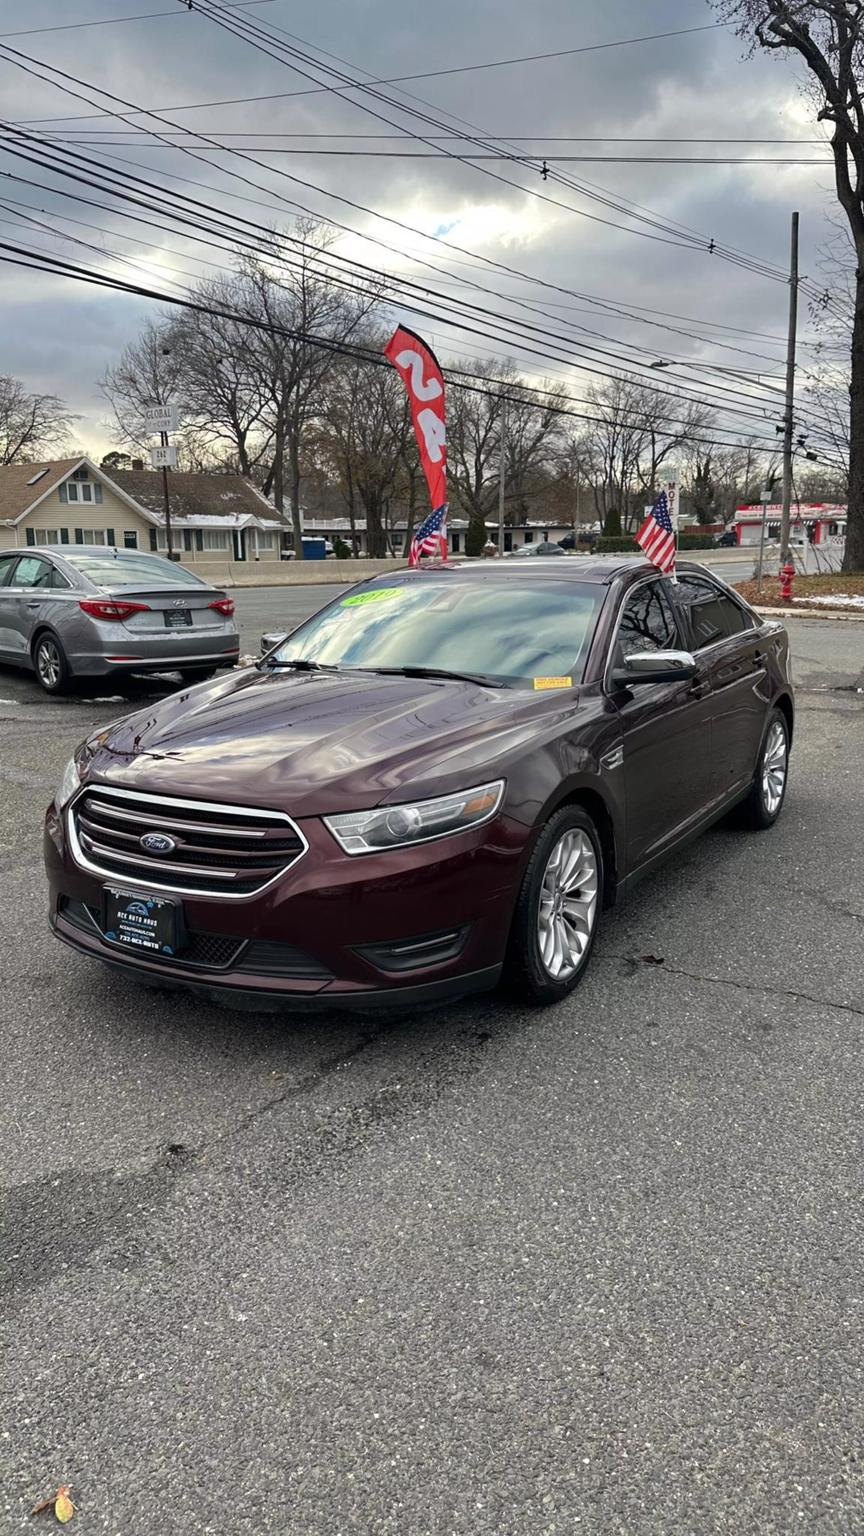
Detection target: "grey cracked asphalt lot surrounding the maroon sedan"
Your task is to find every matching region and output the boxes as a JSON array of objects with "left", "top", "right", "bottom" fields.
[{"left": 0, "top": 588, "right": 864, "bottom": 1536}]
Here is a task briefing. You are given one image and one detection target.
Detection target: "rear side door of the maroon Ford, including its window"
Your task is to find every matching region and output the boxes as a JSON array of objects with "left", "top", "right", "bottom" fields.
[{"left": 675, "top": 573, "right": 769, "bottom": 800}]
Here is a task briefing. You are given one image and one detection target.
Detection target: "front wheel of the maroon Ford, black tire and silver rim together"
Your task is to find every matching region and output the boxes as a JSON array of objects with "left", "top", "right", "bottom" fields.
[{"left": 504, "top": 805, "right": 604, "bottom": 1008}]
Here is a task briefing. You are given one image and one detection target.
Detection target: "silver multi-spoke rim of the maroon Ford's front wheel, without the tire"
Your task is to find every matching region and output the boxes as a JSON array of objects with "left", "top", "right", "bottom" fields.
[{"left": 537, "top": 828, "right": 600, "bottom": 982}]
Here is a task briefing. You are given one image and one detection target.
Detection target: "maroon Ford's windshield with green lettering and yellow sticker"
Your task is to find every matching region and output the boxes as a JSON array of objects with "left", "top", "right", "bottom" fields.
[{"left": 269, "top": 573, "right": 604, "bottom": 688}]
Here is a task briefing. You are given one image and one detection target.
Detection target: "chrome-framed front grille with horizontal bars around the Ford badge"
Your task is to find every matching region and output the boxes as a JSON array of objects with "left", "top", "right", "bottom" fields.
[{"left": 69, "top": 785, "right": 306, "bottom": 899}]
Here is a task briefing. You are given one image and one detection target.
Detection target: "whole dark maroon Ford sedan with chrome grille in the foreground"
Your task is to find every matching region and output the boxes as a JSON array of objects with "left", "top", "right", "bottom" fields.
[{"left": 45, "top": 558, "right": 793, "bottom": 1008}]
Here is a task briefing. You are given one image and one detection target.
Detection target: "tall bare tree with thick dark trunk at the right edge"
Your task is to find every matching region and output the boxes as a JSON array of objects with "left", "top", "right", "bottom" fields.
[{"left": 713, "top": 0, "right": 864, "bottom": 571}]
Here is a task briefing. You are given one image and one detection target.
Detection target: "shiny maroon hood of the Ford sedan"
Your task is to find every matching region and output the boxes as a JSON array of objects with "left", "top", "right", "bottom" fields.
[{"left": 85, "top": 667, "right": 578, "bottom": 816}]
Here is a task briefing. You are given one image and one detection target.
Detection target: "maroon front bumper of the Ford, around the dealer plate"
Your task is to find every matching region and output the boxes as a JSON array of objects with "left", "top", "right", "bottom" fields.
[{"left": 45, "top": 806, "right": 530, "bottom": 1011}]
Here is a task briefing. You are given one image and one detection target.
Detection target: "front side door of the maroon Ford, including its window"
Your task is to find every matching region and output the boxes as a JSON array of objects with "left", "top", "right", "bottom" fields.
[{"left": 607, "top": 576, "right": 712, "bottom": 869}]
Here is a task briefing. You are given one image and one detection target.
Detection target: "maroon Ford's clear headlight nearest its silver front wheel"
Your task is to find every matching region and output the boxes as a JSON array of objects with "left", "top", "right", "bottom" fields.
[{"left": 324, "top": 779, "right": 504, "bottom": 854}]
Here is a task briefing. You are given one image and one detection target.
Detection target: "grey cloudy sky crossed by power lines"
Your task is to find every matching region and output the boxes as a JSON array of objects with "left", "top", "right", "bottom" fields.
[{"left": 0, "top": 0, "right": 832, "bottom": 452}]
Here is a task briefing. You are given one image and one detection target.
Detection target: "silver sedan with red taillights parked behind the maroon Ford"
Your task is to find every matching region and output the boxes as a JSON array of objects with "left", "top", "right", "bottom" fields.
[{"left": 0, "top": 544, "right": 240, "bottom": 693}]
